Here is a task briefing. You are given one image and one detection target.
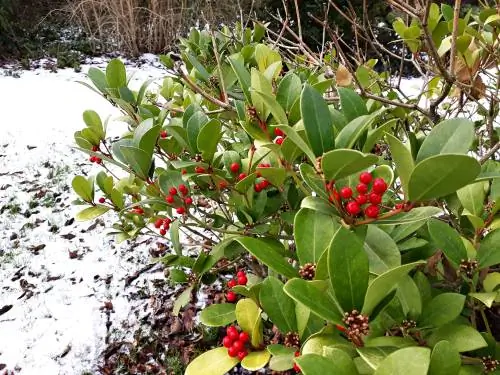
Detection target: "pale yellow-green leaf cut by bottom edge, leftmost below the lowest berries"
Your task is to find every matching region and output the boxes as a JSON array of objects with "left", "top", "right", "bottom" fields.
[{"left": 184, "top": 347, "right": 239, "bottom": 375}]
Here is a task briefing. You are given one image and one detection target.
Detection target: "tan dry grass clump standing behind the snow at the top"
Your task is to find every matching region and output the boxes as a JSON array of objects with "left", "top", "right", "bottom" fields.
[{"left": 66, "top": 0, "right": 258, "bottom": 55}]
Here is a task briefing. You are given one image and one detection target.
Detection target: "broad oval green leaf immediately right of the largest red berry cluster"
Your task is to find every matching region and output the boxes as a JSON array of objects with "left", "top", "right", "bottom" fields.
[{"left": 408, "top": 154, "right": 481, "bottom": 201}]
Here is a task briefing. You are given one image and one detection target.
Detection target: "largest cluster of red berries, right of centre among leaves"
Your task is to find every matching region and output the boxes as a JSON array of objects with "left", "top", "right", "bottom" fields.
[{"left": 330, "top": 172, "right": 387, "bottom": 219}]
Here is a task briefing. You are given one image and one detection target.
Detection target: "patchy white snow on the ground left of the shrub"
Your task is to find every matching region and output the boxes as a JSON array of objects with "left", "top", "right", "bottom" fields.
[{"left": 0, "top": 56, "right": 165, "bottom": 375}]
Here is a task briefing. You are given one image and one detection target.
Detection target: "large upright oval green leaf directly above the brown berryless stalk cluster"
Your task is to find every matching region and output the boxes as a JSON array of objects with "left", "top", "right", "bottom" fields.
[{"left": 328, "top": 227, "right": 369, "bottom": 311}]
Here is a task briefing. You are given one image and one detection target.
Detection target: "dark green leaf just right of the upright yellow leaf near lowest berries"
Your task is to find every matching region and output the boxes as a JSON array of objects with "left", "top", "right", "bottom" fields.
[{"left": 259, "top": 276, "right": 297, "bottom": 332}]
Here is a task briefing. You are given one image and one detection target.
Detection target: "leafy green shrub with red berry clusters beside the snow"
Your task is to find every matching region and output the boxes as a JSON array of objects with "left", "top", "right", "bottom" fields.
[{"left": 73, "top": 4, "right": 500, "bottom": 375}]
